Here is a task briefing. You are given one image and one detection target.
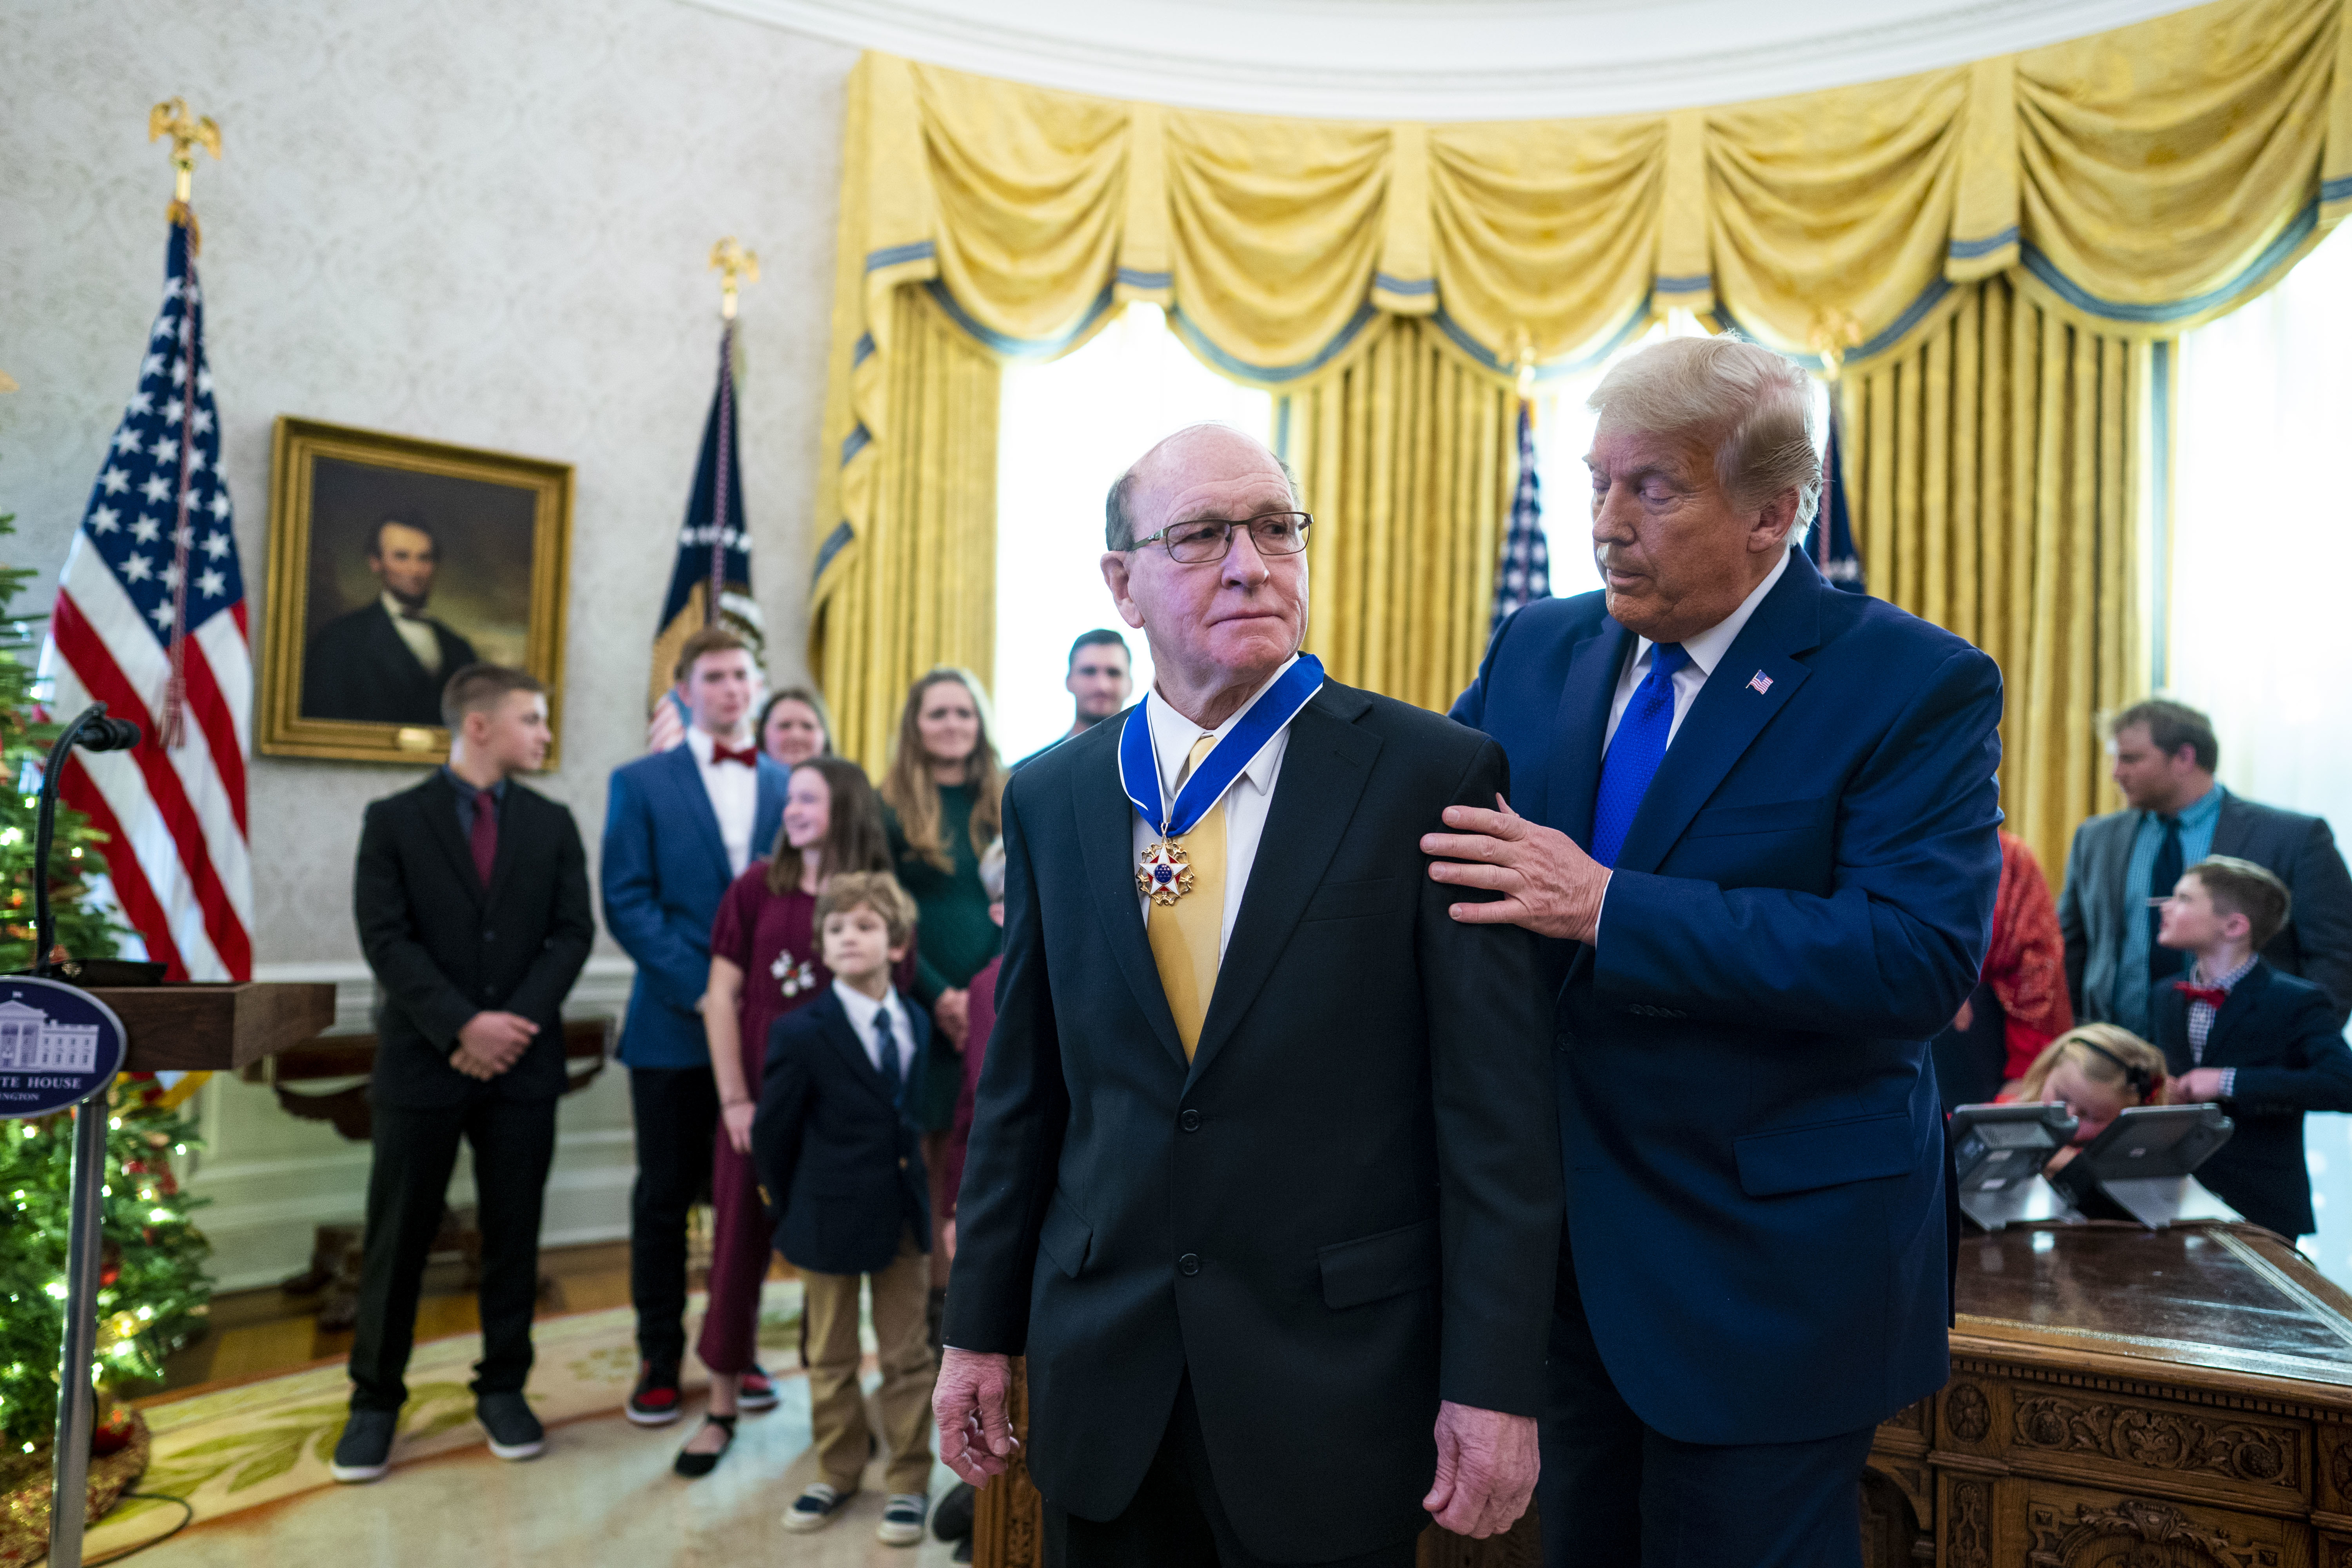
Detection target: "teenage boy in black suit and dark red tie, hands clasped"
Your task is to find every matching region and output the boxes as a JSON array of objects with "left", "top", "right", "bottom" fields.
[{"left": 332, "top": 666, "right": 595, "bottom": 1481}]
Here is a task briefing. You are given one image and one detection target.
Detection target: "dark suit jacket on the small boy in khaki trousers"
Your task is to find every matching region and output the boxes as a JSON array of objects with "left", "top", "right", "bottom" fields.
[{"left": 750, "top": 985, "right": 931, "bottom": 1274}]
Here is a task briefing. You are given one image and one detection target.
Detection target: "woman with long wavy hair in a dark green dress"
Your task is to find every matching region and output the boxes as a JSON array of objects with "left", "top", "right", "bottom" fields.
[{"left": 882, "top": 668, "right": 1004, "bottom": 1338}]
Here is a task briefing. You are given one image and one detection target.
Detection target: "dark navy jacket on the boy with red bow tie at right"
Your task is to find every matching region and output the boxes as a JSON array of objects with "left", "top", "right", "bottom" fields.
[{"left": 2157, "top": 961, "right": 2352, "bottom": 1239}]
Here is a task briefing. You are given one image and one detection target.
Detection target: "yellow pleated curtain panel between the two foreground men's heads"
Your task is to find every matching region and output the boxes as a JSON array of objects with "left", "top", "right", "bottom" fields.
[{"left": 1275, "top": 317, "right": 1515, "bottom": 710}]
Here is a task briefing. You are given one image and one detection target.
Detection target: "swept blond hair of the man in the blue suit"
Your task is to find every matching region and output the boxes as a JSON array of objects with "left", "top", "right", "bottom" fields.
[{"left": 1585, "top": 332, "right": 1820, "bottom": 529}]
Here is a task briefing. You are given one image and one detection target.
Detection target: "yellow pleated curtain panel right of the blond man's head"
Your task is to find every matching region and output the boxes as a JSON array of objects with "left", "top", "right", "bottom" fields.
[{"left": 1842, "top": 278, "right": 2150, "bottom": 874}]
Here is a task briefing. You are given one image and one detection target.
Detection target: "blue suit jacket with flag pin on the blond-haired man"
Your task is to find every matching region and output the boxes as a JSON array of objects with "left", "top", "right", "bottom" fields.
[{"left": 1454, "top": 553, "right": 2002, "bottom": 1443}]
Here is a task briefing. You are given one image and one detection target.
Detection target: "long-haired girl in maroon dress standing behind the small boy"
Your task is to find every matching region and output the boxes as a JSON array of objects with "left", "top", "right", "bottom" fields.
[{"left": 677, "top": 757, "right": 913, "bottom": 1476}]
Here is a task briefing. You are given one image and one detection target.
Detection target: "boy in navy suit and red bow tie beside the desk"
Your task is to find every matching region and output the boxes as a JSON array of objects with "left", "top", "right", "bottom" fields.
[{"left": 2154, "top": 855, "right": 2352, "bottom": 1236}]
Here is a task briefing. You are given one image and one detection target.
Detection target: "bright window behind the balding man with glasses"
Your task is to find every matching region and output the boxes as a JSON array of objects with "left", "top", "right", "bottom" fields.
[{"left": 993, "top": 306, "right": 1272, "bottom": 762}]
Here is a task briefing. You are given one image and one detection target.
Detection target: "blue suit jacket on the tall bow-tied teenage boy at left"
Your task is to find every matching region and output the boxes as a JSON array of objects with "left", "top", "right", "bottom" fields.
[{"left": 597, "top": 745, "right": 790, "bottom": 1067}]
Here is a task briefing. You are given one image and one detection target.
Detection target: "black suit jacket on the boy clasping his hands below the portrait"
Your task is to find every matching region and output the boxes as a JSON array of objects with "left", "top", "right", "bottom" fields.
[{"left": 350, "top": 769, "right": 595, "bottom": 1107}]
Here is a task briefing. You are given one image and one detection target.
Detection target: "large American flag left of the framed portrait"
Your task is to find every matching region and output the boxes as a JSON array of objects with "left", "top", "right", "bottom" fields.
[{"left": 40, "top": 209, "right": 254, "bottom": 980}]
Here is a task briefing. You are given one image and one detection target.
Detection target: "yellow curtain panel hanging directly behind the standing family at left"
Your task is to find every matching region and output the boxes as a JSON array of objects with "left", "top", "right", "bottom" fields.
[{"left": 809, "top": 289, "right": 1000, "bottom": 774}]
